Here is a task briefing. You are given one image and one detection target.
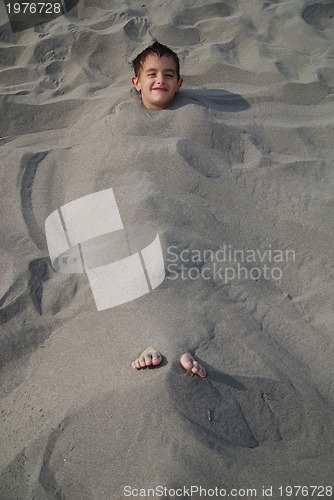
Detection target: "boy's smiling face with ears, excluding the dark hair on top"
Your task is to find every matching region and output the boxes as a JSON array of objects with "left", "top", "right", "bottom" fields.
[{"left": 132, "top": 54, "right": 183, "bottom": 109}]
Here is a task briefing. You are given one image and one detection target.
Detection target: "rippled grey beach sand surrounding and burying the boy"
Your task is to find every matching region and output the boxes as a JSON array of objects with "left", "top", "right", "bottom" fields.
[{"left": 0, "top": 0, "right": 334, "bottom": 500}]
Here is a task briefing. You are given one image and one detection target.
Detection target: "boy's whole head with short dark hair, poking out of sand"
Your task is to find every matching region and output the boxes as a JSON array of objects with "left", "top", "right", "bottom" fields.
[{"left": 132, "top": 42, "right": 183, "bottom": 109}]
